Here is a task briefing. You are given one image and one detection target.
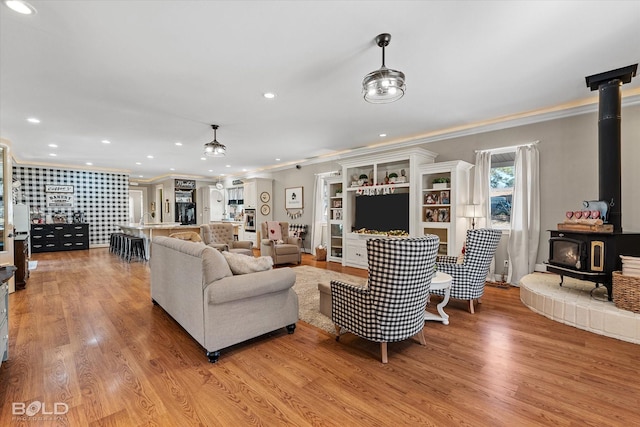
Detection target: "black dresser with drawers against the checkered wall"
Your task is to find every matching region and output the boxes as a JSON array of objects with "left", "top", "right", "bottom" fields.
[{"left": 31, "top": 224, "right": 89, "bottom": 253}]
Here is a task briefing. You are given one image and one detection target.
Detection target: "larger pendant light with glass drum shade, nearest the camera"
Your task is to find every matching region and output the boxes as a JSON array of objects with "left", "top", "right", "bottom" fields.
[{"left": 362, "top": 33, "right": 406, "bottom": 104}]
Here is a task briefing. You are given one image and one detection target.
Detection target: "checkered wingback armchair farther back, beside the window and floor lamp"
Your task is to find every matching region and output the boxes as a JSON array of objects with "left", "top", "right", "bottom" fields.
[{"left": 432, "top": 228, "right": 502, "bottom": 314}]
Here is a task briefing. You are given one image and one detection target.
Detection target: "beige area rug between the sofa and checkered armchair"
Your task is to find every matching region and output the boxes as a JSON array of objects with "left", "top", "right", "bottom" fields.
[{"left": 293, "top": 265, "right": 367, "bottom": 333}]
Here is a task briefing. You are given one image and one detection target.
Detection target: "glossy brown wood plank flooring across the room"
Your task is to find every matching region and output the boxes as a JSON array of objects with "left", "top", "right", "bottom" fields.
[{"left": 0, "top": 248, "right": 640, "bottom": 427}]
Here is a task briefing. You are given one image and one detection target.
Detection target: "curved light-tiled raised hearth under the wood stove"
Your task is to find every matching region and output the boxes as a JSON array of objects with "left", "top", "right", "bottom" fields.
[{"left": 520, "top": 273, "right": 640, "bottom": 344}]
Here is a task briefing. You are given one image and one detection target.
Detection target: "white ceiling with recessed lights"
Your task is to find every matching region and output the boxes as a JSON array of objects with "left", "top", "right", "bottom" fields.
[{"left": 0, "top": 0, "right": 640, "bottom": 180}]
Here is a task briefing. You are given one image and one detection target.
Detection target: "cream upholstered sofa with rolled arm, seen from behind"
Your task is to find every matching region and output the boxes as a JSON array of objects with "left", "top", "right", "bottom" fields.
[{"left": 150, "top": 237, "right": 298, "bottom": 363}]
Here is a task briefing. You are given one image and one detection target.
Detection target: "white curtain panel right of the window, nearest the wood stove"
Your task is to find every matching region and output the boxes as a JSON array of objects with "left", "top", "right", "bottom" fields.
[{"left": 507, "top": 144, "right": 540, "bottom": 285}]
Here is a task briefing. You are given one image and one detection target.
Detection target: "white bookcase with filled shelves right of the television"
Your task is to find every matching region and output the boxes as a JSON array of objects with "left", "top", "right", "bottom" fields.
[{"left": 417, "top": 160, "right": 473, "bottom": 256}]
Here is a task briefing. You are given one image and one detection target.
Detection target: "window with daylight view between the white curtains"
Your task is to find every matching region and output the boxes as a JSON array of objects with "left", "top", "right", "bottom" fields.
[{"left": 489, "top": 150, "right": 516, "bottom": 230}]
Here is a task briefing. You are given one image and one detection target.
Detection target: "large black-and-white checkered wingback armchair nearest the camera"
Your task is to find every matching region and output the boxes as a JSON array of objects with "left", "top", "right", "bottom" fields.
[{"left": 331, "top": 235, "right": 440, "bottom": 363}]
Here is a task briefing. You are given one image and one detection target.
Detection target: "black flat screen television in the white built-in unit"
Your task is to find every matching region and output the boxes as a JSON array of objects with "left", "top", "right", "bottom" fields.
[{"left": 354, "top": 193, "right": 409, "bottom": 233}]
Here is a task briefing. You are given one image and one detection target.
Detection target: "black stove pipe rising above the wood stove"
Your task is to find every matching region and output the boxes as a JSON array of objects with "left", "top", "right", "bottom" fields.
[{"left": 585, "top": 64, "right": 638, "bottom": 233}]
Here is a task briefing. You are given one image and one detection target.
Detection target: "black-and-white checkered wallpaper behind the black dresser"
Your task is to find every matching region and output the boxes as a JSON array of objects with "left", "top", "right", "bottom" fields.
[{"left": 13, "top": 166, "right": 129, "bottom": 246}]
